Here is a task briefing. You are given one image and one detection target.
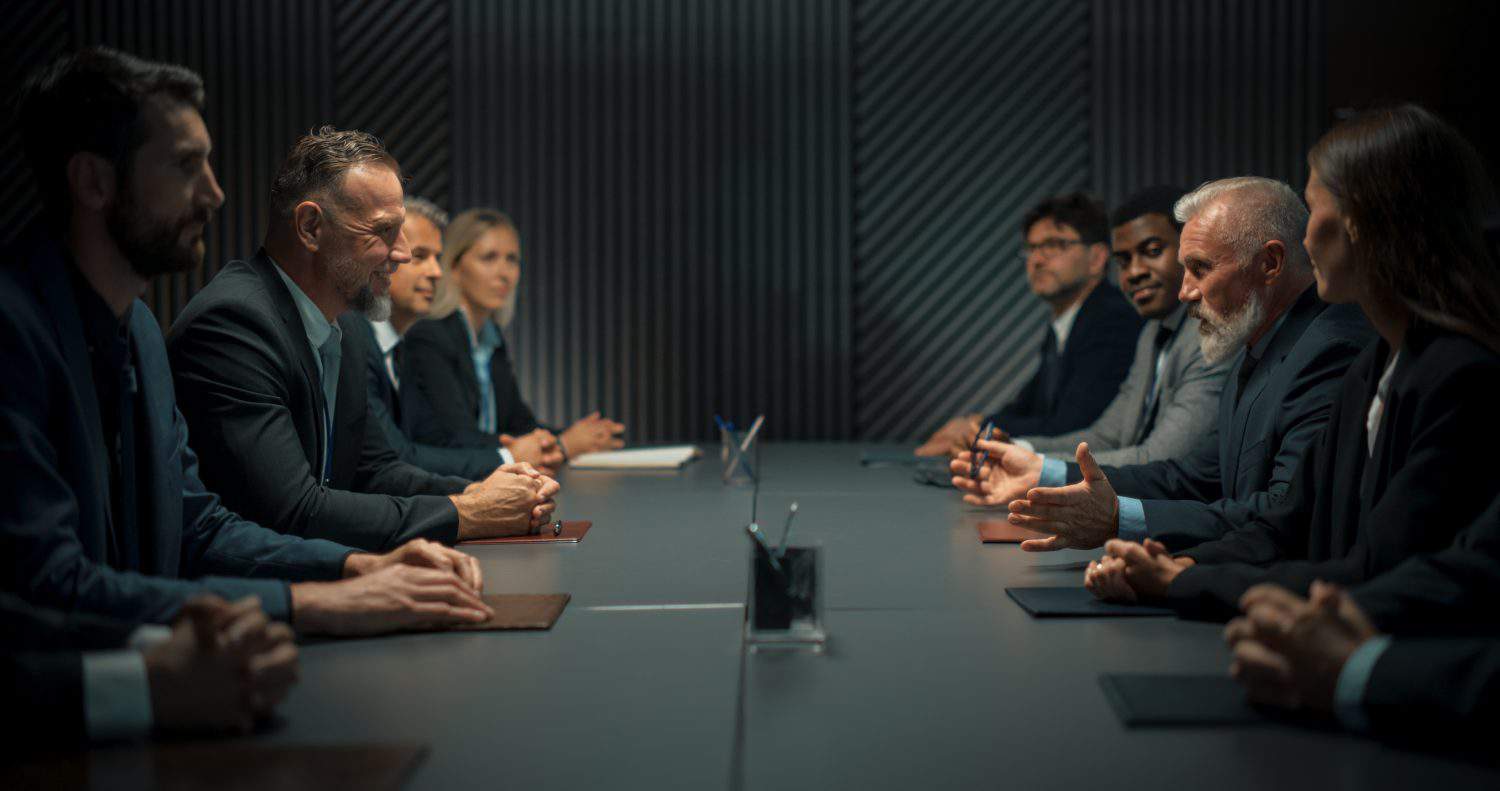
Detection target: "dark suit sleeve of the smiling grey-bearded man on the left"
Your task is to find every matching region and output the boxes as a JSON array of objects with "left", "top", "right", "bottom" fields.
[{"left": 171, "top": 305, "right": 458, "bottom": 551}]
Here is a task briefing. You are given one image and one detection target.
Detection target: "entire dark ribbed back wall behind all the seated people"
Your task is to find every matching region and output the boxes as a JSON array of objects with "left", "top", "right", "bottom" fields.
[{"left": 0, "top": 0, "right": 1500, "bottom": 441}]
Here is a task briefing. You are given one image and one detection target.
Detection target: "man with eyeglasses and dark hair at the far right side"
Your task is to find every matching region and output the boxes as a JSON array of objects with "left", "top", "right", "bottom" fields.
[{"left": 917, "top": 192, "right": 1142, "bottom": 456}]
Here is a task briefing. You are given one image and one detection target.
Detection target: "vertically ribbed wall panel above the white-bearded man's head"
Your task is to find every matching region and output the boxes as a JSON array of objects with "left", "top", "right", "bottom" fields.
[{"left": 1092, "top": 0, "right": 1329, "bottom": 207}]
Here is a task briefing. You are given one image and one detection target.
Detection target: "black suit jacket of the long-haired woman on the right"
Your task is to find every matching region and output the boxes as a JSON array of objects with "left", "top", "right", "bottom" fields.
[{"left": 1169, "top": 323, "right": 1500, "bottom": 617}]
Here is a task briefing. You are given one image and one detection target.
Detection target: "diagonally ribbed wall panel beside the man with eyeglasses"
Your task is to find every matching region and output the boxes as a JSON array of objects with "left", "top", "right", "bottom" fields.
[{"left": 854, "top": 0, "right": 1091, "bottom": 440}]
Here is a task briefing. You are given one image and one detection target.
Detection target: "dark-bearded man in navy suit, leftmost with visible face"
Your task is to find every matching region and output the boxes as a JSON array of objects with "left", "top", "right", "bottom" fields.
[{"left": 0, "top": 48, "right": 501, "bottom": 633}]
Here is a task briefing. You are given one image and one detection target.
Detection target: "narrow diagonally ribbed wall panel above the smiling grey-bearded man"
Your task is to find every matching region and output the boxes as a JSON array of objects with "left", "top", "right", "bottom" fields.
[{"left": 332, "top": 0, "right": 452, "bottom": 204}]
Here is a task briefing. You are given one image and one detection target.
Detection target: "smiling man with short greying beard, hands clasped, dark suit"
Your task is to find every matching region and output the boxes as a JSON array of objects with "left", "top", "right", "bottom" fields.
[{"left": 168, "top": 126, "right": 558, "bottom": 549}]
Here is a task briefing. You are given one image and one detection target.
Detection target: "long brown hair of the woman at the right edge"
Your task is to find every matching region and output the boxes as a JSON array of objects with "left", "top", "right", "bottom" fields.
[{"left": 1308, "top": 105, "right": 1500, "bottom": 353}]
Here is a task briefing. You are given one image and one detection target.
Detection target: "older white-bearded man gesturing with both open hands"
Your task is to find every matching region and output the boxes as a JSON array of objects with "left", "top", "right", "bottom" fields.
[{"left": 953, "top": 177, "right": 1373, "bottom": 552}]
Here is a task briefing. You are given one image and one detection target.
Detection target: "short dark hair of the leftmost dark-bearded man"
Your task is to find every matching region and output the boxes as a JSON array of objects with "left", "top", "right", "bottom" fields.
[{"left": 17, "top": 47, "right": 204, "bottom": 224}]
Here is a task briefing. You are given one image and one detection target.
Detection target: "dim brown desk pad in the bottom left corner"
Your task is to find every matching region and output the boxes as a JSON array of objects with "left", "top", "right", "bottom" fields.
[{"left": 0, "top": 740, "right": 428, "bottom": 791}]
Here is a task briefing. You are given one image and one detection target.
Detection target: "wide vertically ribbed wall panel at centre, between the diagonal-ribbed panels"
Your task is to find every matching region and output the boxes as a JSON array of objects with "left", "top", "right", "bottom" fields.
[{"left": 452, "top": 0, "right": 852, "bottom": 441}]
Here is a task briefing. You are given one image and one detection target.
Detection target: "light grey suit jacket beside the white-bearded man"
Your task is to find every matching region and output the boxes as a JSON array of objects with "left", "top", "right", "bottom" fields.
[{"left": 1026, "top": 305, "right": 1229, "bottom": 464}]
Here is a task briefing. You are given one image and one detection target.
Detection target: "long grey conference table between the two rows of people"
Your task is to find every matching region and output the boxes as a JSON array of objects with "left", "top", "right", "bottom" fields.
[{"left": 270, "top": 443, "right": 1500, "bottom": 791}]
